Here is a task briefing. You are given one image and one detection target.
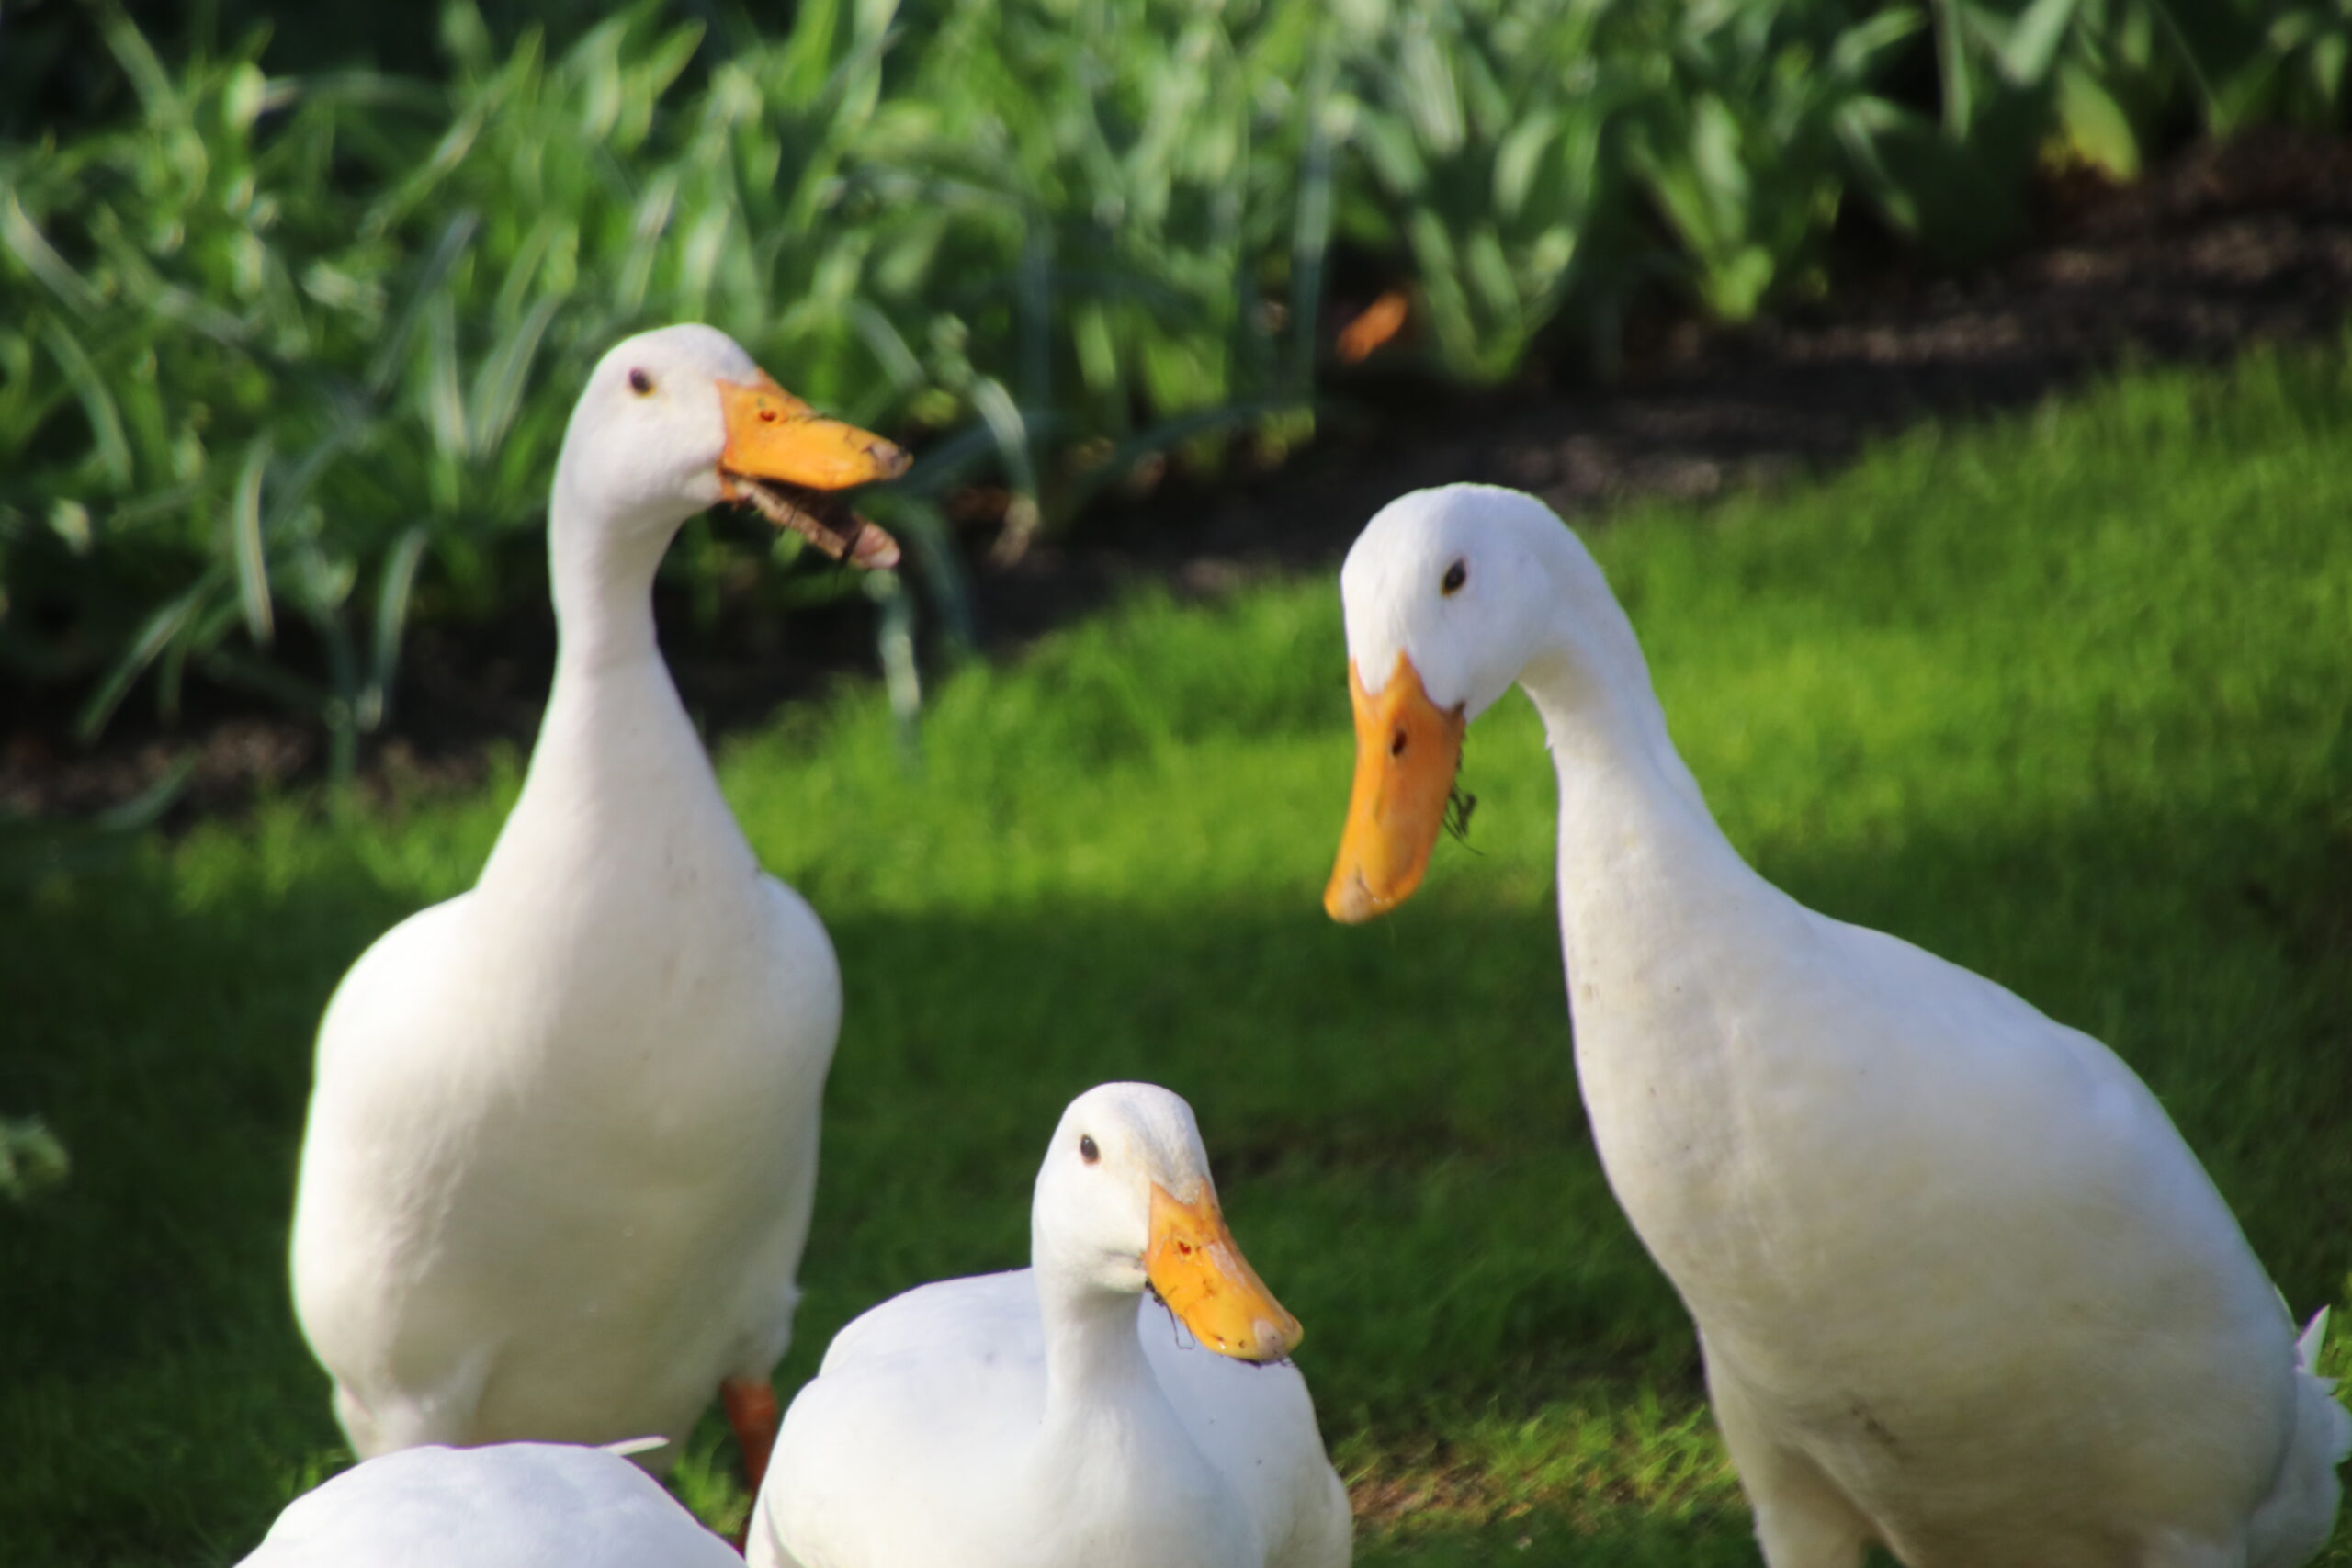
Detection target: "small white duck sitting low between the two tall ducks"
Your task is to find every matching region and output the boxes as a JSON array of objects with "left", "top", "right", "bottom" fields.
[{"left": 748, "top": 1084, "right": 1350, "bottom": 1568}]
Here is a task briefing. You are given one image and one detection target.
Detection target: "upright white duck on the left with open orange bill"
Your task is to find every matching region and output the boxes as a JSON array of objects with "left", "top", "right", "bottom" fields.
[{"left": 294, "top": 327, "right": 906, "bottom": 1483}]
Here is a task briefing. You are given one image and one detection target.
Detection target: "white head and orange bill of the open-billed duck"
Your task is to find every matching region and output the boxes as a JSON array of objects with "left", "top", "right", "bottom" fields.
[{"left": 555, "top": 324, "right": 906, "bottom": 564}]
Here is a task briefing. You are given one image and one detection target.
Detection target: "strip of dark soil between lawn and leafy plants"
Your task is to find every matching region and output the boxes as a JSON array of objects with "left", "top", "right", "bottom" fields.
[{"left": 0, "top": 131, "right": 2352, "bottom": 820}]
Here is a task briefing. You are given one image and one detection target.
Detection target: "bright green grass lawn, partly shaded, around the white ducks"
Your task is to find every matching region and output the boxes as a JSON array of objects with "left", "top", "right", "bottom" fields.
[{"left": 0, "top": 355, "right": 2352, "bottom": 1568}]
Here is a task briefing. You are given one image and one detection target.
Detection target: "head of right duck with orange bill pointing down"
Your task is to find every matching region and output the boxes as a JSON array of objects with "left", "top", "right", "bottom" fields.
[{"left": 1324, "top": 484, "right": 1590, "bottom": 924}]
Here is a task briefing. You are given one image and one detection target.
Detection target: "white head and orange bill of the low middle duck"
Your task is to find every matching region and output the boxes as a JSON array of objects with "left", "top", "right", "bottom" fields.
[{"left": 1030, "top": 1084, "right": 1303, "bottom": 1361}]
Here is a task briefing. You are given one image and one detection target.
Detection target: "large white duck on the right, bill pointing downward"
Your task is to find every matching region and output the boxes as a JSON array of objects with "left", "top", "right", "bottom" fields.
[{"left": 1324, "top": 484, "right": 2352, "bottom": 1568}]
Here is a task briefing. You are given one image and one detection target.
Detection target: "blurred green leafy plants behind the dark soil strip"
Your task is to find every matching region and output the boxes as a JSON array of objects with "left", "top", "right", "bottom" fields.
[{"left": 0, "top": 0, "right": 2352, "bottom": 761}]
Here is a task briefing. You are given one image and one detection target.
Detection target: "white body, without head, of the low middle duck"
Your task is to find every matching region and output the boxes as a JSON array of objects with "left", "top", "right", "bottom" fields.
[{"left": 748, "top": 1086, "right": 1350, "bottom": 1568}]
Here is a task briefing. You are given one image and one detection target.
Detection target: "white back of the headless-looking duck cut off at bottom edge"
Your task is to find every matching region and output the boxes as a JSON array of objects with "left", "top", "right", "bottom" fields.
[{"left": 238, "top": 1443, "right": 743, "bottom": 1568}]
